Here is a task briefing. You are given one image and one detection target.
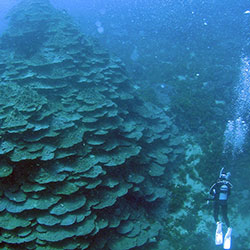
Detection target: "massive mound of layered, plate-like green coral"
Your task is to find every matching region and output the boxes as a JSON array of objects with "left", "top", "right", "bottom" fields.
[{"left": 0, "top": 0, "right": 181, "bottom": 250}]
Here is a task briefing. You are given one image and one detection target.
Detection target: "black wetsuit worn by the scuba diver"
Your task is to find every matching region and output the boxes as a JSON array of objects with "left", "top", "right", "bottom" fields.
[{"left": 209, "top": 180, "right": 233, "bottom": 227}]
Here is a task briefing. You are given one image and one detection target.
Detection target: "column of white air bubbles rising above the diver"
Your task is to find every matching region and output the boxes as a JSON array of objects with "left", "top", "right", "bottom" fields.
[{"left": 224, "top": 57, "right": 250, "bottom": 156}]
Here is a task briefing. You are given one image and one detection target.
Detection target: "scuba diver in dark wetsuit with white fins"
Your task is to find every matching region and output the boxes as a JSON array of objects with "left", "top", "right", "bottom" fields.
[{"left": 208, "top": 168, "right": 233, "bottom": 249}]
